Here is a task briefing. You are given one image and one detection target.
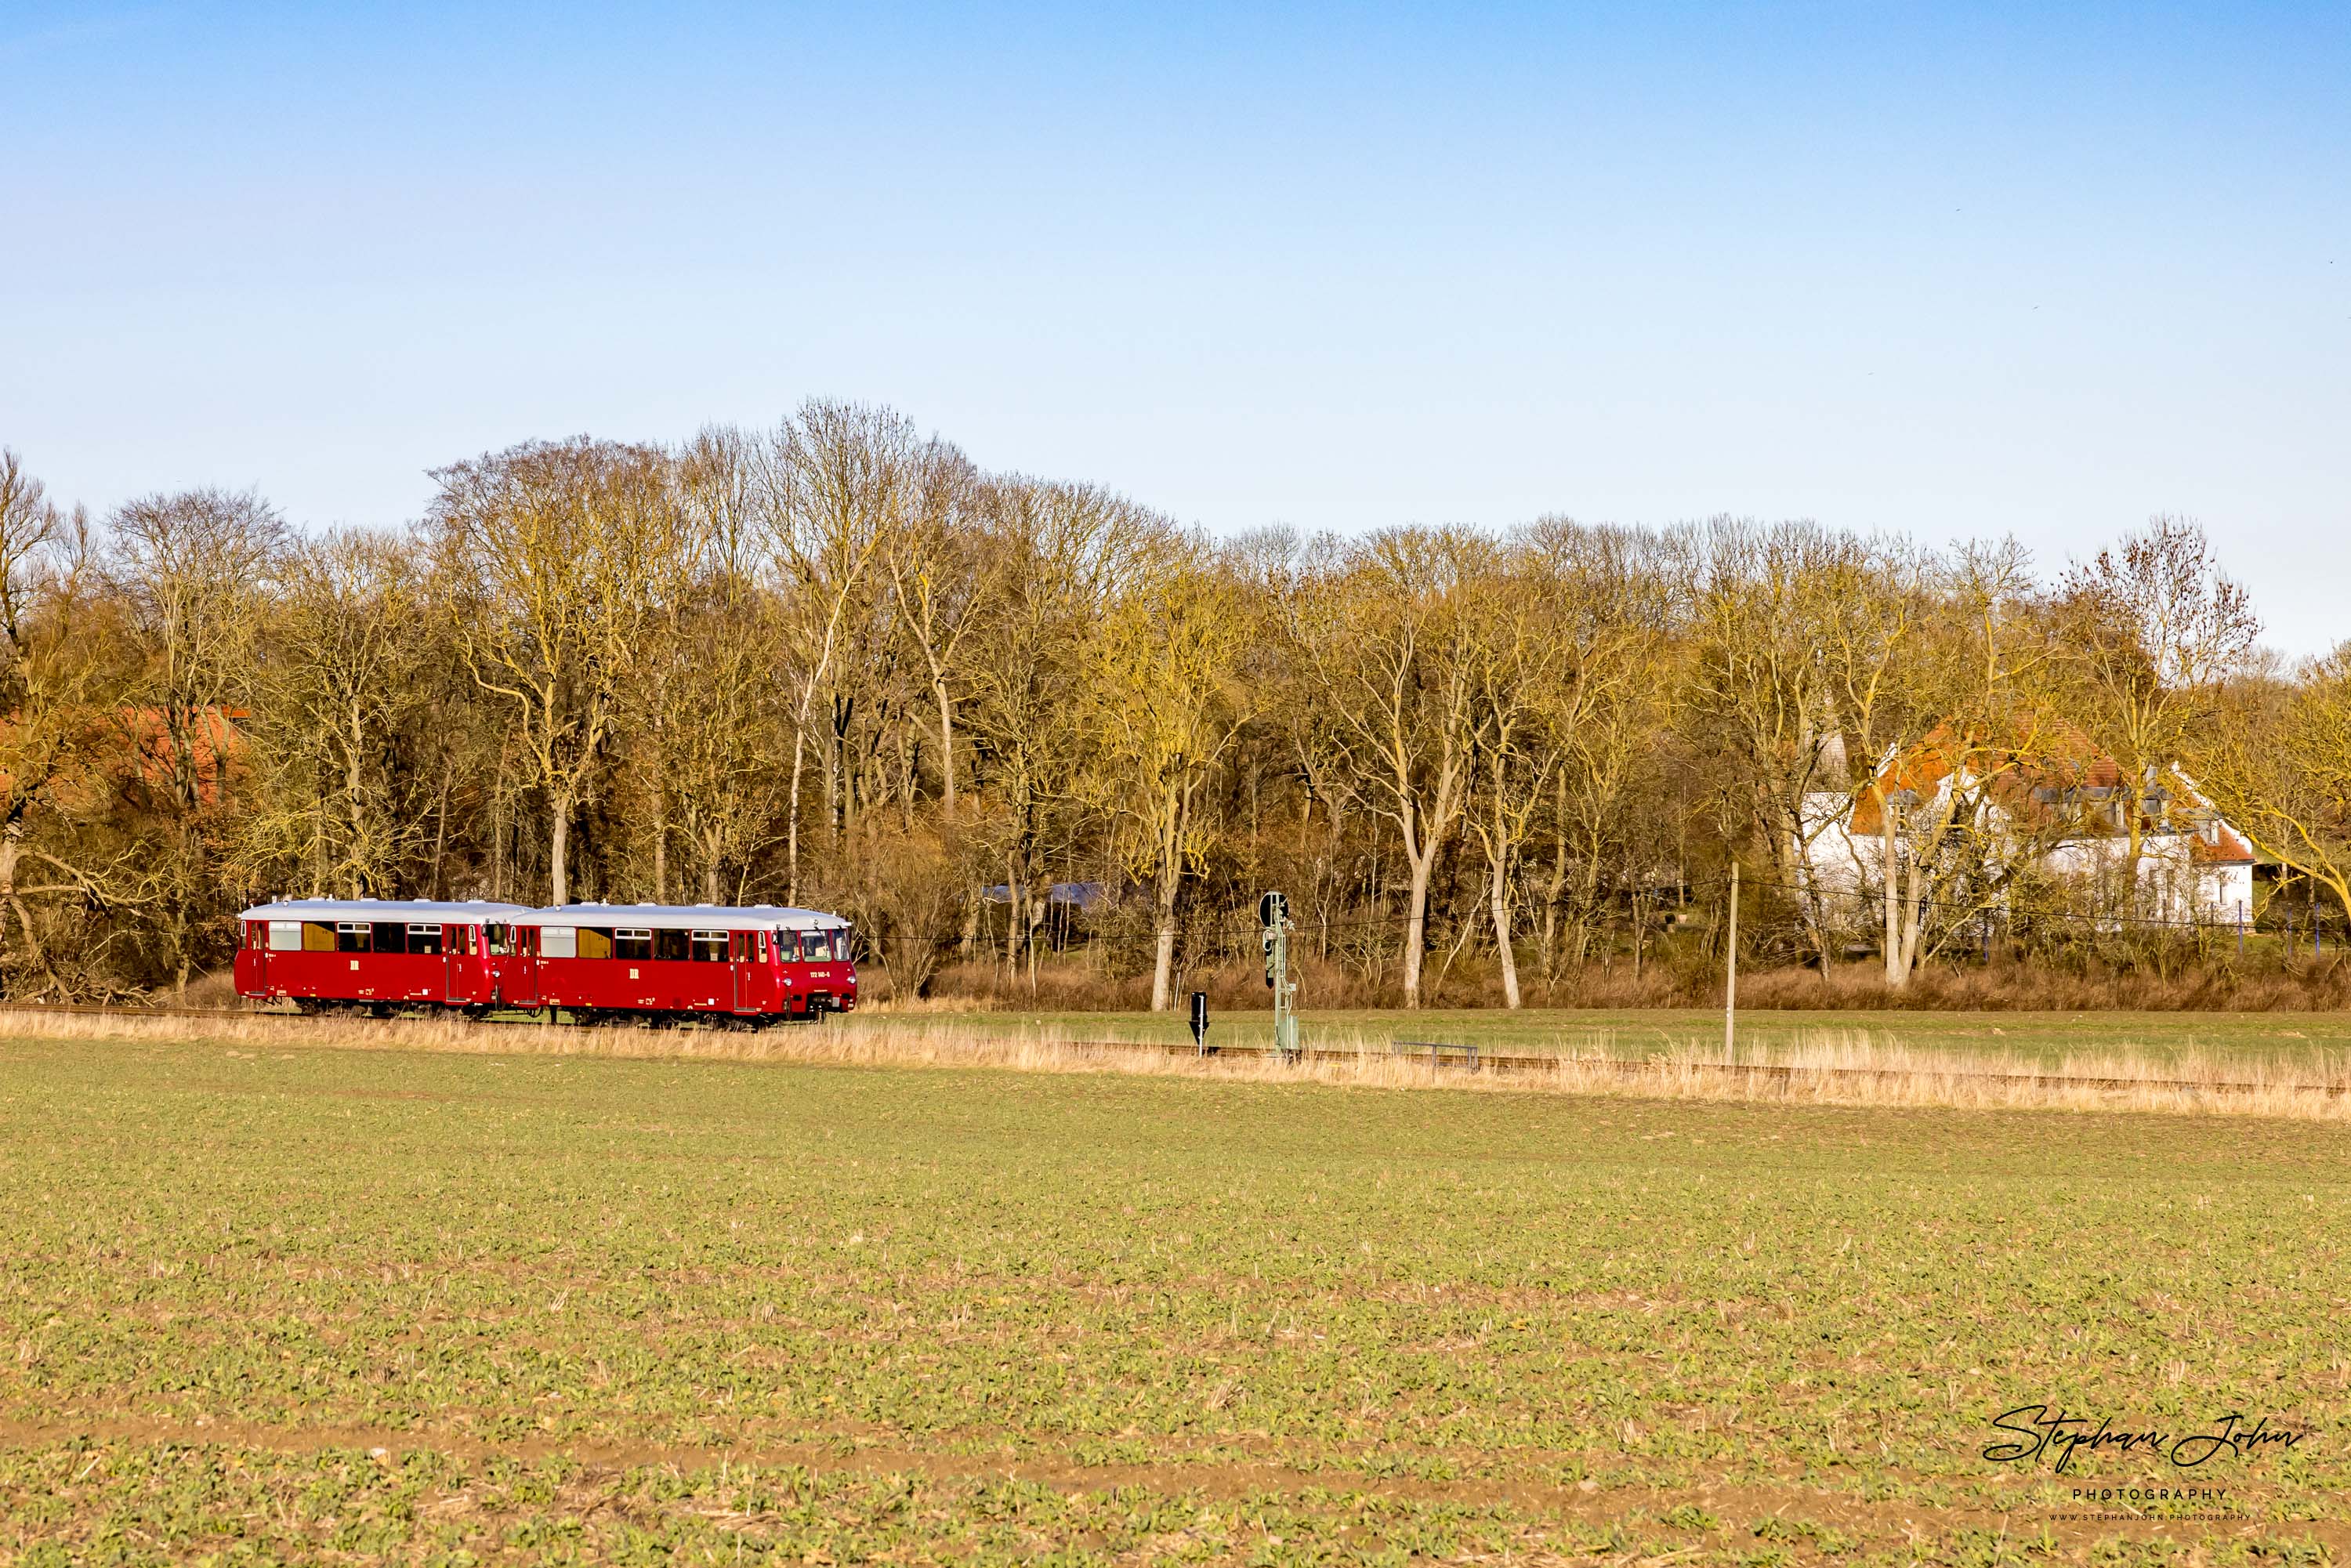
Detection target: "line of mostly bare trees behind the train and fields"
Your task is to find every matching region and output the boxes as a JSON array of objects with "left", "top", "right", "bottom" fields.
[{"left": 0, "top": 400, "right": 2351, "bottom": 1006}]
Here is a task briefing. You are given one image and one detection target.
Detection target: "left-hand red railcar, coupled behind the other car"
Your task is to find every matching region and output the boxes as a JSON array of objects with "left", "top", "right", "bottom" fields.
[{"left": 237, "top": 898, "right": 529, "bottom": 1013}]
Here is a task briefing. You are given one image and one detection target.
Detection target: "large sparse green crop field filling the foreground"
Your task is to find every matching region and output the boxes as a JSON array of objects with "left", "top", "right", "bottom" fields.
[{"left": 0, "top": 1020, "right": 2351, "bottom": 1563}]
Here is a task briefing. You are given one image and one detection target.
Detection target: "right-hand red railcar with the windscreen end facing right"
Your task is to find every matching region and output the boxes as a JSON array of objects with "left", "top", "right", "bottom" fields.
[{"left": 508, "top": 903, "right": 858, "bottom": 1023}]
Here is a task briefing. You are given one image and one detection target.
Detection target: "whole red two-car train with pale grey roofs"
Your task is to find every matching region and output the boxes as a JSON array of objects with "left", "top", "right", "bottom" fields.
[{"left": 237, "top": 898, "right": 858, "bottom": 1025}]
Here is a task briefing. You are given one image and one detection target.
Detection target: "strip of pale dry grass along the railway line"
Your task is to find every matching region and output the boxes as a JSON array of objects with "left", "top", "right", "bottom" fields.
[{"left": 5, "top": 1011, "right": 2351, "bottom": 1121}]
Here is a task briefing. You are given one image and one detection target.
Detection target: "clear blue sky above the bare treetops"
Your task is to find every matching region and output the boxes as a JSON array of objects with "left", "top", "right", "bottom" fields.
[{"left": 0, "top": 0, "right": 2351, "bottom": 651}]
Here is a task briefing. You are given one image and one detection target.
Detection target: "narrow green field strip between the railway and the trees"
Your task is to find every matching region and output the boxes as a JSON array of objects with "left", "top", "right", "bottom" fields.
[{"left": 893, "top": 1009, "right": 2351, "bottom": 1067}]
